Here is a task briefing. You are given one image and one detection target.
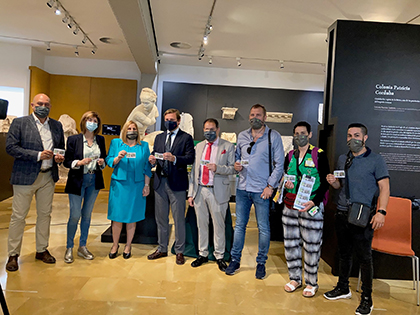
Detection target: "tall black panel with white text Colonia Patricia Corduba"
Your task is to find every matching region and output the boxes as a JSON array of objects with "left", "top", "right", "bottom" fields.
[{"left": 320, "top": 21, "right": 420, "bottom": 279}]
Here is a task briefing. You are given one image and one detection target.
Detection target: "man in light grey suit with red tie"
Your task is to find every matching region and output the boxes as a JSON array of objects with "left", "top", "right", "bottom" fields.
[{"left": 188, "top": 118, "right": 235, "bottom": 272}]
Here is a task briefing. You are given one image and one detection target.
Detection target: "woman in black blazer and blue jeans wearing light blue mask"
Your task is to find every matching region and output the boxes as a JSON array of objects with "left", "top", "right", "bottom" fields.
[{"left": 64, "top": 111, "right": 106, "bottom": 263}]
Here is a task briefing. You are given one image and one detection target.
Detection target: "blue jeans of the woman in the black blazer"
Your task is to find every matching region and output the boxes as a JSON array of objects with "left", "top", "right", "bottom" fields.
[{"left": 67, "top": 174, "right": 99, "bottom": 248}]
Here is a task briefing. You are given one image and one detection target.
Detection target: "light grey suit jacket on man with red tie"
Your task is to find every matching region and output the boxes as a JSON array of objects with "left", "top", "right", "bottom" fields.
[{"left": 188, "top": 138, "right": 235, "bottom": 204}]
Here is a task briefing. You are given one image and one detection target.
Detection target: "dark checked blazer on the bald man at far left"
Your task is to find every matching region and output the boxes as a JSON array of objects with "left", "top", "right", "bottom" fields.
[{"left": 6, "top": 115, "right": 64, "bottom": 185}]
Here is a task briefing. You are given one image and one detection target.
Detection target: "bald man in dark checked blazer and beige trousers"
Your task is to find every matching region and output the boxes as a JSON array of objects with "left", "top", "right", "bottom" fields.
[{"left": 6, "top": 94, "right": 64, "bottom": 271}]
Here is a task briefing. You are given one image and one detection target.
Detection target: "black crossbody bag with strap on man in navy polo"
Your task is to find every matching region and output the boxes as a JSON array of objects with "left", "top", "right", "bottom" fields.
[{"left": 344, "top": 152, "right": 376, "bottom": 228}]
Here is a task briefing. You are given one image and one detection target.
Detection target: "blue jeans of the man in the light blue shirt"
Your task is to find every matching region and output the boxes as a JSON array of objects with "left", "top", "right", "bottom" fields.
[{"left": 231, "top": 189, "right": 270, "bottom": 264}]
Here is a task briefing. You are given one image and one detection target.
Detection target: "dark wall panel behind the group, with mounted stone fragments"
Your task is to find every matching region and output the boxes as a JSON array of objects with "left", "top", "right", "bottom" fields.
[{"left": 161, "top": 82, "right": 323, "bottom": 143}]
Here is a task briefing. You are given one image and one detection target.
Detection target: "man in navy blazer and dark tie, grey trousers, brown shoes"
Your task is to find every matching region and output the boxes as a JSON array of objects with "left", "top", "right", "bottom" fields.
[{"left": 147, "top": 108, "right": 195, "bottom": 265}]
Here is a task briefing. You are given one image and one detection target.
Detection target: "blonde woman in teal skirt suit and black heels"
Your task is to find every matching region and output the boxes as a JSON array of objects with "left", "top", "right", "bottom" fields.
[{"left": 106, "top": 121, "right": 152, "bottom": 259}]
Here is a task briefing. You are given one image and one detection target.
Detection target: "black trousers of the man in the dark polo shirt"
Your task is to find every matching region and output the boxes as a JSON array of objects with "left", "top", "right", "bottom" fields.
[{"left": 335, "top": 210, "right": 373, "bottom": 297}]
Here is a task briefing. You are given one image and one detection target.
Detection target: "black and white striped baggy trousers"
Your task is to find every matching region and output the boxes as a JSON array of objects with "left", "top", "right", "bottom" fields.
[{"left": 282, "top": 203, "right": 324, "bottom": 286}]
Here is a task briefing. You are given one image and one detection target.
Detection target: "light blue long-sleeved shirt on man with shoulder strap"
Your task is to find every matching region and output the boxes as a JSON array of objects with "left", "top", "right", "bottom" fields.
[{"left": 235, "top": 126, "right": 284, "bottom": 193}]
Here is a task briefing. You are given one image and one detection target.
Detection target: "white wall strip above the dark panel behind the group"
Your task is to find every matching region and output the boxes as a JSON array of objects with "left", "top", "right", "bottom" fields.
[{"left": 156, "top": 64, "right": 325, "bottom": 130}]
